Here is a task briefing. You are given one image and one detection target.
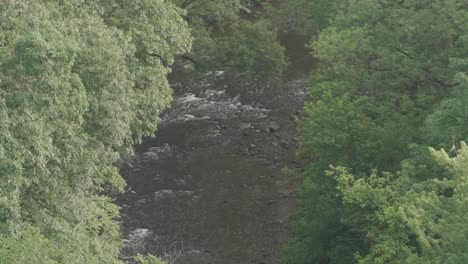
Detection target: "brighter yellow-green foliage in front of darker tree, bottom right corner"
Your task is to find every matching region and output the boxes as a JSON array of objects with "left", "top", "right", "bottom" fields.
[{"left": 329, "top": 142, "right": 468, "bottom": 263}]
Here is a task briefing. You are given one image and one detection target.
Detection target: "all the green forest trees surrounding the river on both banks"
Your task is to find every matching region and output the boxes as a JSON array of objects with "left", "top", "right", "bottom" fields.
[{"left": 0, "top": 0, "right": 468, "bottom": 264}]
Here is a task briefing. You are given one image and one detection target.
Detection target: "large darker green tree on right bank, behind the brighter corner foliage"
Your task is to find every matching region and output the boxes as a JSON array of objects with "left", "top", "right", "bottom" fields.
[{"left": 283, "top": 0, "right": 468, "bottom": 264}]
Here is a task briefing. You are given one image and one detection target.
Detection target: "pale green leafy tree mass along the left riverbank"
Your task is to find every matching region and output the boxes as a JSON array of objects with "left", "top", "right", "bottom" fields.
[{"left": 0, "top": 0, "right": 190, "bottom": 263}]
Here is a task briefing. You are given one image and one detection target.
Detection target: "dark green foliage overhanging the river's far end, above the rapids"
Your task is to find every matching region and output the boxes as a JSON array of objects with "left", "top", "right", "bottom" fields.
[{"left": 172, "top": 0, "right": 285, "bottom": 77}]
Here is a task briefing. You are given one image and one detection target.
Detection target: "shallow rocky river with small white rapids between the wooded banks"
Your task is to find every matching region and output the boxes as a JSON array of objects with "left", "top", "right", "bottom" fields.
[{"left": 118, "top": 72, "right": 306, "bottom": 264}]
